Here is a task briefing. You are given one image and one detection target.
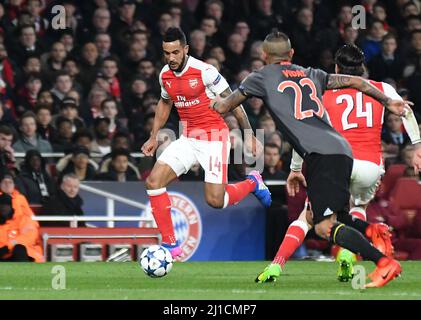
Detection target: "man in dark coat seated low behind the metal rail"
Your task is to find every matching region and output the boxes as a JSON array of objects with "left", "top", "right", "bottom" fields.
[{"left": 42, "top": 173, "right": 85, "bottom": 227}]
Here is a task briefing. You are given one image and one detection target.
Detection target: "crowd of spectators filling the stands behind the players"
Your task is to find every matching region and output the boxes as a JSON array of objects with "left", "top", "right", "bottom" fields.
[{"left": 0, "top": 0, "right": 421, "bottom": 259}]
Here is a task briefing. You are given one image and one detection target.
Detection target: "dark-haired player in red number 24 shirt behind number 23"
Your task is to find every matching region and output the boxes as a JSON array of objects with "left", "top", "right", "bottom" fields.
[{"left": 323, "top": 45, "right": 421, "bottom": 281}]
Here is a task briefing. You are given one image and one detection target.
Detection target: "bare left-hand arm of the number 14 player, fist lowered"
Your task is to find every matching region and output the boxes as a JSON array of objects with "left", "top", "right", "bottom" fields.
[{"left": 142, "top": 97, "right": 172, "bottom": 157}]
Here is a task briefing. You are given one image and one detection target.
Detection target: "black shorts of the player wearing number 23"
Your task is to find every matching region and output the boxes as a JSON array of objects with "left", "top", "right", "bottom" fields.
[{"left": 304, "top": 153, "right": 353, "bottom": 225}]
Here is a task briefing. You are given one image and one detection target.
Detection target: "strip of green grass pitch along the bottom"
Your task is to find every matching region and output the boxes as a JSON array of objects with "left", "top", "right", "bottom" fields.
[{"left": 0, "top": 261, "right": 421, "bottom": 300}]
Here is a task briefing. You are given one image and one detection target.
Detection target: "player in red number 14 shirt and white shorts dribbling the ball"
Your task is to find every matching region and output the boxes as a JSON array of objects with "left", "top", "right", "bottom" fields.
[{"left": 142, "top": 28, "right": 271, "bottom": 257}]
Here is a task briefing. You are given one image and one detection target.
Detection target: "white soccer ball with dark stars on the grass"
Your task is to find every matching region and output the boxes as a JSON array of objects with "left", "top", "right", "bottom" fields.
[{"left": 139, "top": 245, "right": 173, "bottom": 278}]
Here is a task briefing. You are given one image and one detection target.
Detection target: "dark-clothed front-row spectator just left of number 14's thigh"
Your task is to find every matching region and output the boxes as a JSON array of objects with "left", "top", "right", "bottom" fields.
[{"left": 96, "top": 149, "right": 140, "bottom": 182}]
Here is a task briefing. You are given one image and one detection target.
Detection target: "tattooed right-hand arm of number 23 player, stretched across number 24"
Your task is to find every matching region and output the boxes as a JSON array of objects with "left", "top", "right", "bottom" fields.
[{"left": 327, "top": 74, "right": 413, "bottom": 116}]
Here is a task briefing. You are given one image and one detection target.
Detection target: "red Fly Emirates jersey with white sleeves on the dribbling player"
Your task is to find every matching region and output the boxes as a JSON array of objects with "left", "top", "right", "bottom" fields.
[{"left": 159, "top": 56, "right": 229, "bottom": 140}]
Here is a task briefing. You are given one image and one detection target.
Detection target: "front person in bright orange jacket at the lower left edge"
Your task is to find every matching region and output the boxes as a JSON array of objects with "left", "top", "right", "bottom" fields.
[{"left": 0, "top": 193, "right": 45, "bottom": 262}]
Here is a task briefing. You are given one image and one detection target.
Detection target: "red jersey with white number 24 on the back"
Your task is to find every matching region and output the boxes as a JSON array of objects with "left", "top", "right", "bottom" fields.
[{"left": 323, "top": 80, "right": 402, "bottom": 164}]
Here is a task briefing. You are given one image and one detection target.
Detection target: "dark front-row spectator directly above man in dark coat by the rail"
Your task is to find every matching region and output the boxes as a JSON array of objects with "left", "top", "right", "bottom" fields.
[{"left": 57, "top": 146, "right": 98, "bottom": 181}]
